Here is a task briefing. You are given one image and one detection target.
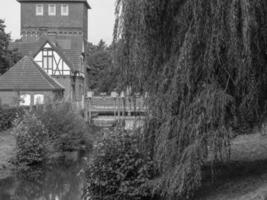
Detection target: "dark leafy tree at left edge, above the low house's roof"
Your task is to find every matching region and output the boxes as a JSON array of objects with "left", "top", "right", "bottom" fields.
[{"left": 0, "top": 19, "right": 21, "bottom": 75}]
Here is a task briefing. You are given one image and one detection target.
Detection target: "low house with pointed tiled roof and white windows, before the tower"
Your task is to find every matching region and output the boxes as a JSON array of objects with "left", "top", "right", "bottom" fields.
[{"left": 0, "top": 56, "right": 65, "bottom": 106}]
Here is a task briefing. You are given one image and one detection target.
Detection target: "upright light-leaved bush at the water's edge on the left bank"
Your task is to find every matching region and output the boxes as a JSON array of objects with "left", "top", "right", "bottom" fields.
[{"left": 13, "top": 113, "right": 48, "bottom": 167}]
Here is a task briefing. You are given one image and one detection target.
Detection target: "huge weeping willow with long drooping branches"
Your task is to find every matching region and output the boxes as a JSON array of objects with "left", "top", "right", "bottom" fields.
[{"left": 114, "top": 0, "right": 267, "bottom": 199}]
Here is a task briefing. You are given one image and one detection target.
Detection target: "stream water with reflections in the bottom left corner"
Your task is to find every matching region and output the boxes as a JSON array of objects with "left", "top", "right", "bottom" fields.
[{"left": 0, "top": 159, "right": 86, "bottom": 200}]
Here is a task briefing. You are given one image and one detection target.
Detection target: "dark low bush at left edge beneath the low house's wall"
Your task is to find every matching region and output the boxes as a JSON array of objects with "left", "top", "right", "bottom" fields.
[{"left": 0, "top": 107, "right": 24, "bottom": 132}]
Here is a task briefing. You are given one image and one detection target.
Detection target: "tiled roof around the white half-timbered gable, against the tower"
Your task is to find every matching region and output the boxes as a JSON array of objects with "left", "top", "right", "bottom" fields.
[{"left": 9, "top": 36, "right": 83, "bottom": 72}]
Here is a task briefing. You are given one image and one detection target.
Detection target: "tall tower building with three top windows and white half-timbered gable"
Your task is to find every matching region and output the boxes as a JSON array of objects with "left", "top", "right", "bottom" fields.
[{"left": 0, "top": 0, "right": 90, "bottom": 108}]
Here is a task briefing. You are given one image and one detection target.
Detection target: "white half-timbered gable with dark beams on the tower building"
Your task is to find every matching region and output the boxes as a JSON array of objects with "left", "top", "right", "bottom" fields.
[{"left": 34, "top": 42, "right": 71, "bottom": 76}]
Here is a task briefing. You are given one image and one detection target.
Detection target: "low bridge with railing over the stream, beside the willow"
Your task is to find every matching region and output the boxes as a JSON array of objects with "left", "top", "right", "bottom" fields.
[{"left": 85, "top": 96, "right": 147, "bottom": 127}]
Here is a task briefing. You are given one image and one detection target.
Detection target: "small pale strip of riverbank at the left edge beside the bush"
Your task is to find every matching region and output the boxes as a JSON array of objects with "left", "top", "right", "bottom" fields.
[{"left": 0, "top": 130, "right": 16, "bottom": 180}]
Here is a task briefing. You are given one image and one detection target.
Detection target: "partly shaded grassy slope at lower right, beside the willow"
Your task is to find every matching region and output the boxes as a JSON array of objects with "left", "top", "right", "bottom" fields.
[{"left": 195, "top": 133, "right": 267, "bottom": 200}]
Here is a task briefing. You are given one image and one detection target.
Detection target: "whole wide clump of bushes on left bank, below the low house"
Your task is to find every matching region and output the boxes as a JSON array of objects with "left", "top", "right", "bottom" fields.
[{"left": 13, "top": 104, "right": 92, "bottom": 167}]
